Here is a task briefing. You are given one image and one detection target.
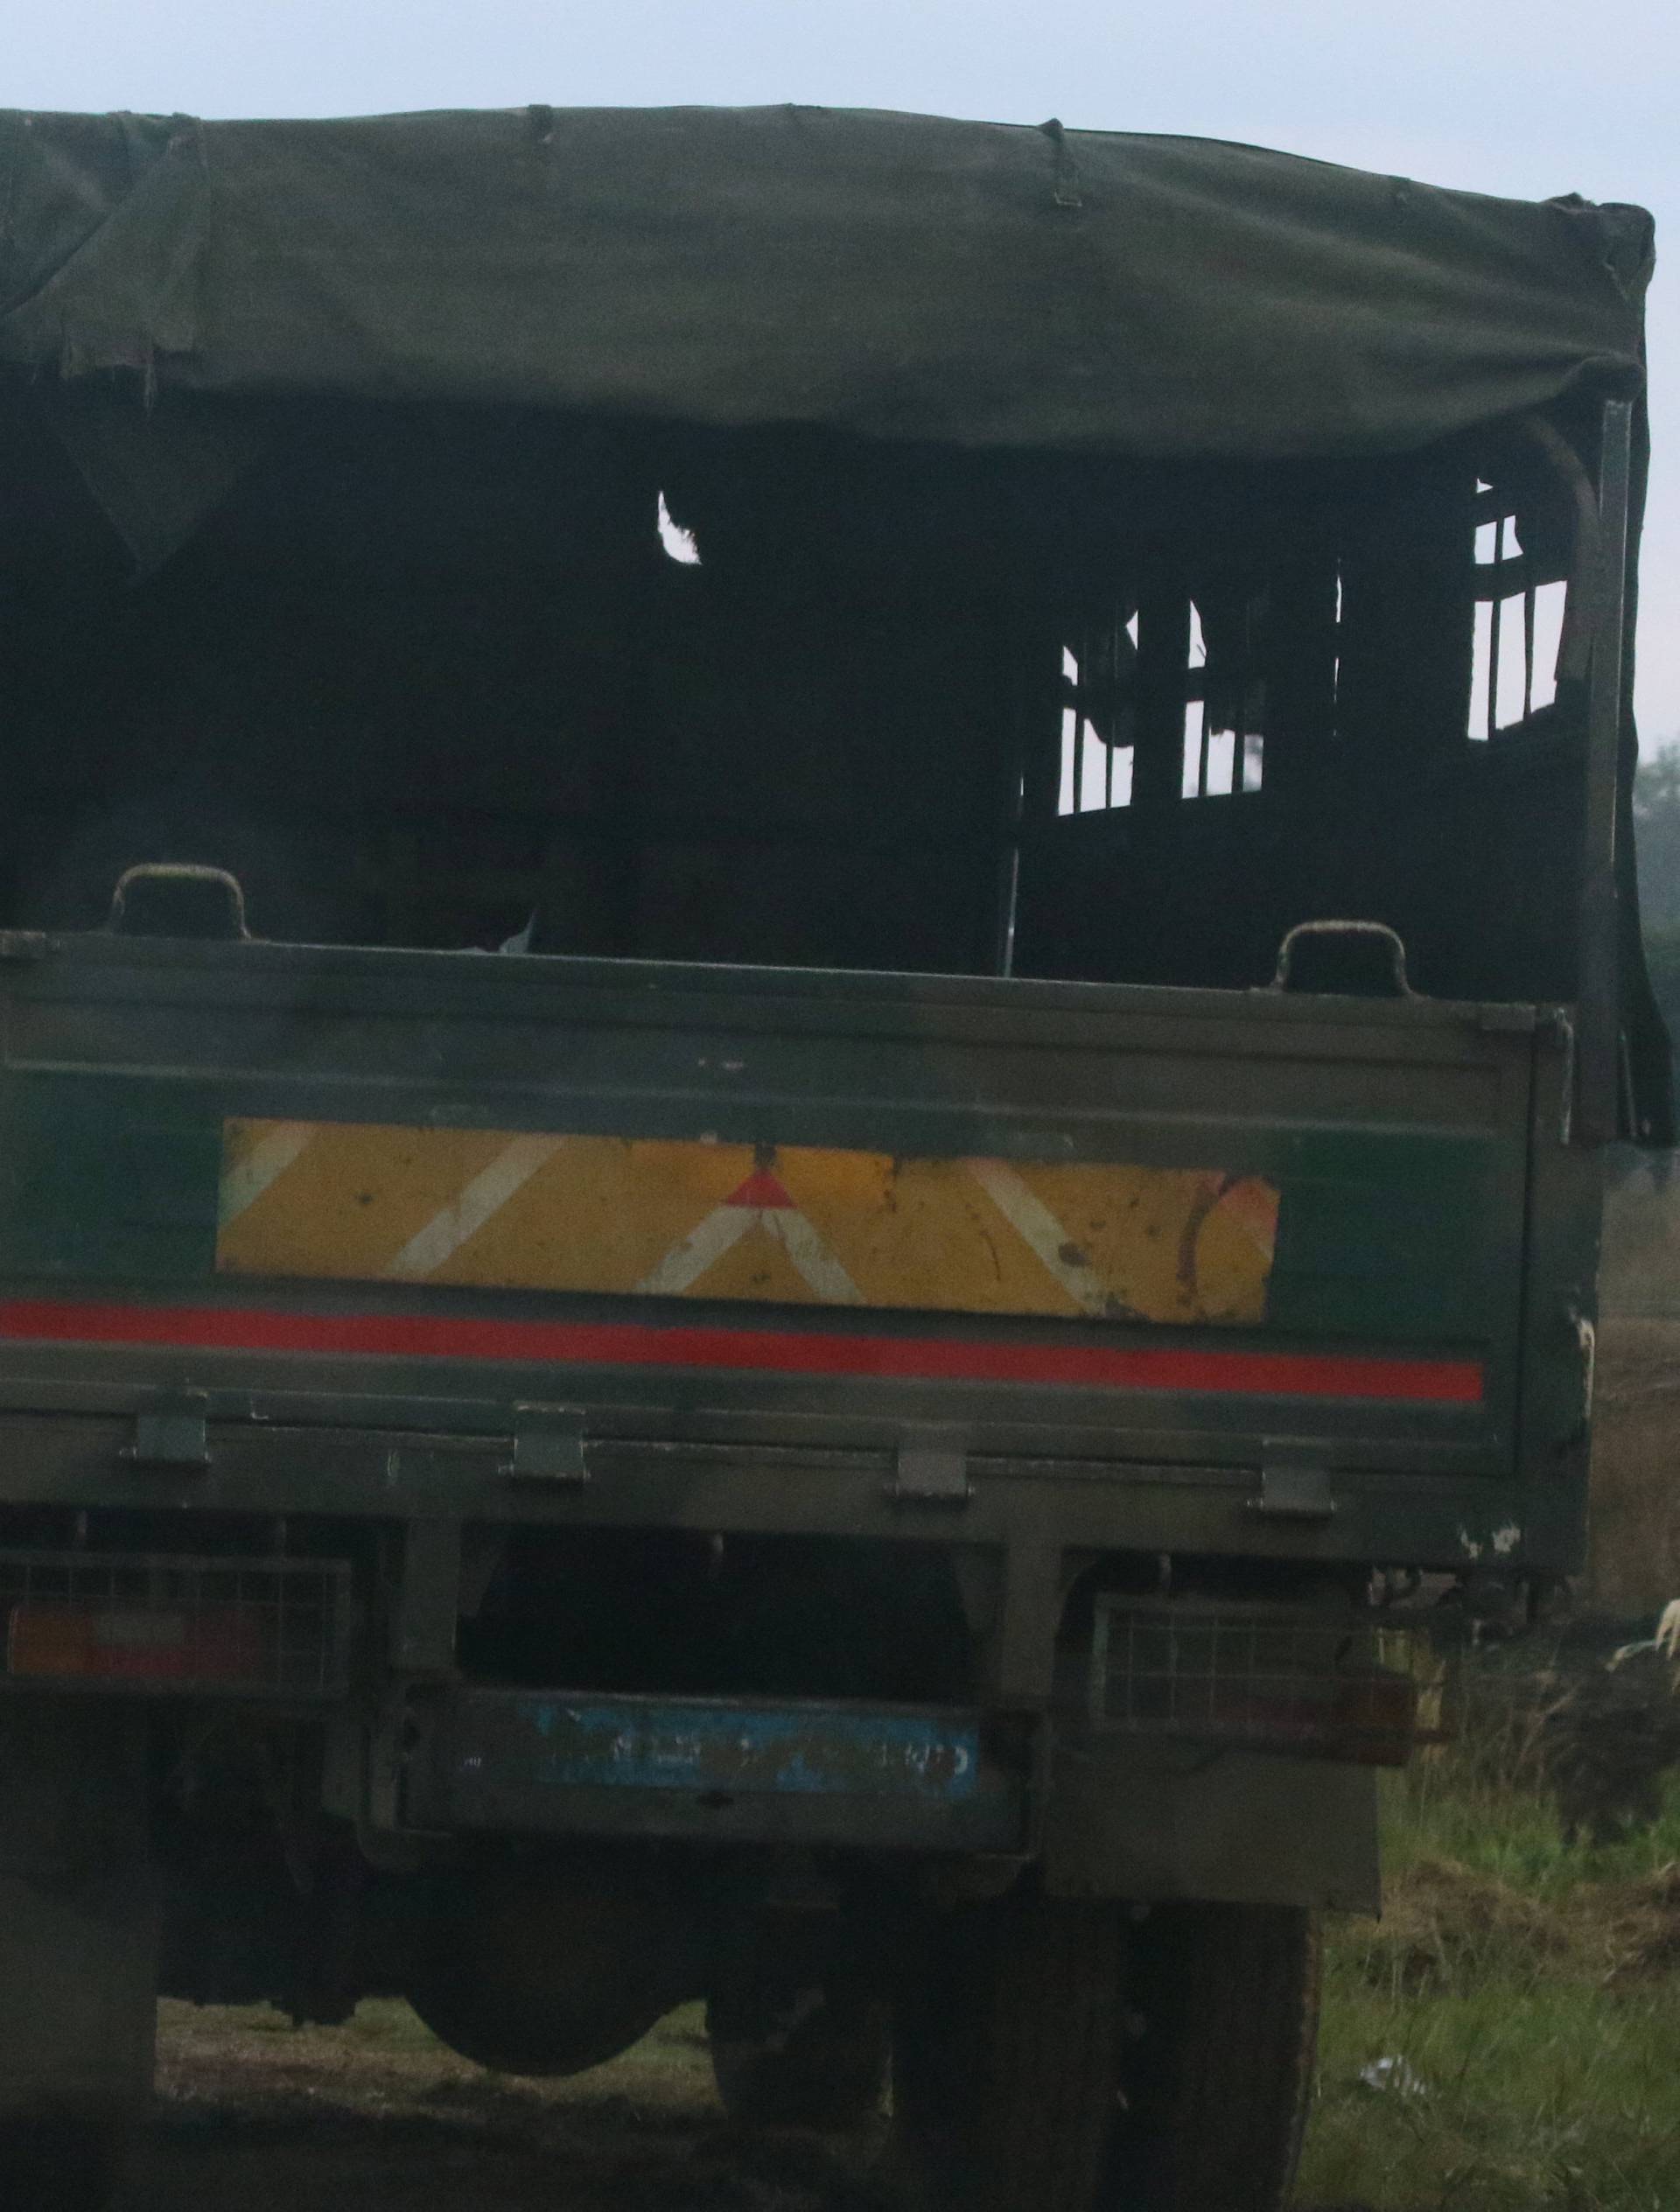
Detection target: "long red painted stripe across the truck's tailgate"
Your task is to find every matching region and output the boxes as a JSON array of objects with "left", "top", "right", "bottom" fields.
[{"left": 0, "top": 1298, "right": 1483, "bottom": 1404}]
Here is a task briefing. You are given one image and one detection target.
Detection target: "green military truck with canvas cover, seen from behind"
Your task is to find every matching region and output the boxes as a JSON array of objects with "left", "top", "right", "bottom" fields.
[{"left": 0, "top": 106, "right": 1671, "bottom": 2212}]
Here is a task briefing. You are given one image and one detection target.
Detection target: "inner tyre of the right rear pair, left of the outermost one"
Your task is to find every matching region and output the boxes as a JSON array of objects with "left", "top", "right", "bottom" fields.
[{"left": 887, "top": 1894, "right": 1124, "bottom": 2212}]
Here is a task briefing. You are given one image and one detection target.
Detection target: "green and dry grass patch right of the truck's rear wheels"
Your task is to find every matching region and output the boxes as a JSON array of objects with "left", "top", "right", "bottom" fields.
[{"left": 1299, "top": 1756, "right": 1680, "bottom": 2212}]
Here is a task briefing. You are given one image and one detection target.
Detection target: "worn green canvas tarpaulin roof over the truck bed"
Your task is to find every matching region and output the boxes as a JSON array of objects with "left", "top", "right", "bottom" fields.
[{"left": 0, "top": 106, "right": 1651, "bottom": 460}]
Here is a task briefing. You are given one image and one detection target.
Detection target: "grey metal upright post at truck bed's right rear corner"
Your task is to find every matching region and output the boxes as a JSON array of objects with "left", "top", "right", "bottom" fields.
[{"left": 1574, "top": 401, "right": 1634, "bottom": 1144}]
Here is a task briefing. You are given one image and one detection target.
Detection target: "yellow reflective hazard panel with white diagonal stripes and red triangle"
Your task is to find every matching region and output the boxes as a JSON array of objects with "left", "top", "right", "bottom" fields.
[{"left": 217, "top": 1122, "right": 1278, "bottom": 1323}]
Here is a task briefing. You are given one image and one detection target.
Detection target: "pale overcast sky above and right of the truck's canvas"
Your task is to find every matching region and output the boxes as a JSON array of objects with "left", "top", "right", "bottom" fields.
[{"left": 0, "top": 0, "right": 1680, "bottom": 747}]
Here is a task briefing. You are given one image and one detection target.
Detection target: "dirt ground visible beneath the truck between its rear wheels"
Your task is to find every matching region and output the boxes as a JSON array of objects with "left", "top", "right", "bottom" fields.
[{"left": 120, "top": 2004, "right": 883, "bottom": 2212}]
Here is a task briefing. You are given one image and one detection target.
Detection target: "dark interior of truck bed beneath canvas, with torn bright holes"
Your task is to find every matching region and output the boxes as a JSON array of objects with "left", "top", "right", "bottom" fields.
[{"left": 0, "top": 387, "right": 1656, "bottom": 1026}]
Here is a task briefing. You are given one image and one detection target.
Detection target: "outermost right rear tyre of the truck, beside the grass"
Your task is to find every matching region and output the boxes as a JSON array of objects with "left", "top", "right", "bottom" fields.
[{"left": 1109, "top": 1905, "right": 1320, "bottom": 2212}]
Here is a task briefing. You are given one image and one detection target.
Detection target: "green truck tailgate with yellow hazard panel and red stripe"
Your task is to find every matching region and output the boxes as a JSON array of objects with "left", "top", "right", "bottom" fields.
[{"left": 0, "top": 935, "right": 1534, "bottom": 1475}]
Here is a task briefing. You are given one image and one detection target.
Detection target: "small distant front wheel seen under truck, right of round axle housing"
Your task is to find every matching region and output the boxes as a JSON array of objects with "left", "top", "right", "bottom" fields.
[{"left": 706, "top": 1989, "right": 890, "bottom": 2135}]
